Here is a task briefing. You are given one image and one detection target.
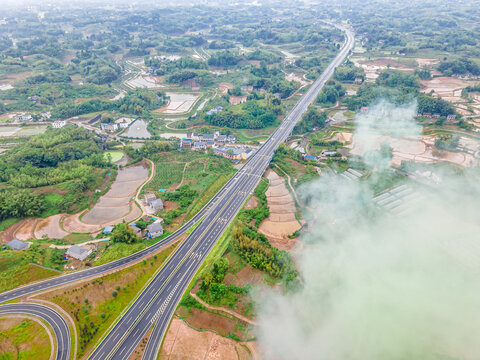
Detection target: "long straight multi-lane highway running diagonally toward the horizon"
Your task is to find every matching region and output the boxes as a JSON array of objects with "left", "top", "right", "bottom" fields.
[{"left": 89, "top": 25, "right": 354, "bottom": 360}]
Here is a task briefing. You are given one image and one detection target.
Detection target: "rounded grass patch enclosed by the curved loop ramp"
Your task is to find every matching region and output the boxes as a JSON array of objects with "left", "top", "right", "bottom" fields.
[{"left": 0, "top": 318, "right": 52, "bottom": 360}]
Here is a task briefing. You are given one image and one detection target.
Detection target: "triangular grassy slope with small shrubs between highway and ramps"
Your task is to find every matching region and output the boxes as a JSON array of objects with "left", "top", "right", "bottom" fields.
[{"left": 40, "top": 244, "right": 176, "bottom": 357}]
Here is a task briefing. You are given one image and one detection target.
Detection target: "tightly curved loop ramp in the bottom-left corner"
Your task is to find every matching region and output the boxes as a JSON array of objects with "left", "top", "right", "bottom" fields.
[{"left": 0, "top": 303, "right": 71, "bottom": 360}]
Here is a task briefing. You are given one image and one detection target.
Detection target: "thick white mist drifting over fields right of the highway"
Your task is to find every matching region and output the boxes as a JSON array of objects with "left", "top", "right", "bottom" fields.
[{"left": 256, "top": 101, "right": 480, "bottom": 360}]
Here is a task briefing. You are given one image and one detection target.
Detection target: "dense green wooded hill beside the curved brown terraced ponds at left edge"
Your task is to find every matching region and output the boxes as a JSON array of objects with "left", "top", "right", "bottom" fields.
[{"left": 0, "top": 126, "right": 107, "bottom": 220}]
